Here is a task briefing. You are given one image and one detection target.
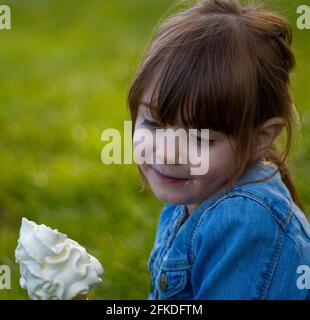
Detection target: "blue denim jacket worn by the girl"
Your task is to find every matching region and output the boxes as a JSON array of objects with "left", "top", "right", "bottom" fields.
[{"left": 147, "top": 162, "right": 310, "bottom": 300}]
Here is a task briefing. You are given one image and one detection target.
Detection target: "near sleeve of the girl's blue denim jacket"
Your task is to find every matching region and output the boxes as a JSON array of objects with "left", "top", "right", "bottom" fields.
[{"left": 192, "top": 196, "right": 304, "bottom": 299}]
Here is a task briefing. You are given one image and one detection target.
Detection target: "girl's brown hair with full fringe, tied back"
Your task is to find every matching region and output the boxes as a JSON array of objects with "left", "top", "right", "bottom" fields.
[{"left": 128, "top": 0, "right": 302, "bottom": 207}]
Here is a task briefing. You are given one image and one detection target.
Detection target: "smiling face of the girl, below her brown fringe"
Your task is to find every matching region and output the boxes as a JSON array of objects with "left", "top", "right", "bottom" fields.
[{"left": 134, "top": 90, "right": 235, "bottom": 211}]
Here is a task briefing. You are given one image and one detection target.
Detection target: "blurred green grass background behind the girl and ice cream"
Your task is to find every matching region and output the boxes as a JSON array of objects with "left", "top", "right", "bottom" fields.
[{"left": 0, "top": 0, "right": 310, "bottom": 299}]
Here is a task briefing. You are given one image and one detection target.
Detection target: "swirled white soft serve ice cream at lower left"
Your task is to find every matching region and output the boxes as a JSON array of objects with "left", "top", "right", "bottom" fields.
[{"left": 15, "top": 218, "right": 104, "bottom": 300}]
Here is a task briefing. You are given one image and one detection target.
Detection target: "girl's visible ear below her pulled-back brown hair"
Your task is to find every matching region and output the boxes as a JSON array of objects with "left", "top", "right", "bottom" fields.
[{"left": 256, "top": 117, "right": 285, "bottom": 155}]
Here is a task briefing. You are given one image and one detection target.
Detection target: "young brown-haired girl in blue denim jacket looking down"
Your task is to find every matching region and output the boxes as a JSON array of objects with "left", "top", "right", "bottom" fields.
[{"left": 128, "top": 0, "right": 310, "bottom": 299}]
